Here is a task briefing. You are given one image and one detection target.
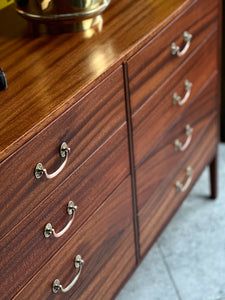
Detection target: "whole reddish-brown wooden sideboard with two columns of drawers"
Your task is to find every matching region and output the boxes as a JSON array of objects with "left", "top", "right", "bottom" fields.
[{"left": 0, "top": 0, "right": 222, "bottom": 300}]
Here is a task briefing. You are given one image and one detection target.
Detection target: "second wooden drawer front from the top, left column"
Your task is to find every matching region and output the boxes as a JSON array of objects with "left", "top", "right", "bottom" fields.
[{"left": 0, "top": 126, "right": 129, "bottom": 297}]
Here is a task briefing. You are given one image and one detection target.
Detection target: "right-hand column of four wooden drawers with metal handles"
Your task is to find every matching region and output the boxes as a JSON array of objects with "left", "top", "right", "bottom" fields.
[{"left": 127, "top": 0, "right": 219, "bottom": 256}]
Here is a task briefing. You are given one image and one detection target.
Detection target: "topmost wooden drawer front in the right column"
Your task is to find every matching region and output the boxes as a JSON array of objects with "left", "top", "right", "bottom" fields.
[{"left": 128, "top": 0, "right": 218, "bottom": 113}]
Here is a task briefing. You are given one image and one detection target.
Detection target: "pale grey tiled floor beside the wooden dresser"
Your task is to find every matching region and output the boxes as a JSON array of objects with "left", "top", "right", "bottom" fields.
[{"left": 116, "top": 144, "right": 225, "bottom": 300}]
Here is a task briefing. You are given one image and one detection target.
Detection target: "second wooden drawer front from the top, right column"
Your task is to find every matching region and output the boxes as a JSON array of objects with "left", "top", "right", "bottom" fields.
[{"left": 132, "top": 32, "right": 218, "bottom": 166}]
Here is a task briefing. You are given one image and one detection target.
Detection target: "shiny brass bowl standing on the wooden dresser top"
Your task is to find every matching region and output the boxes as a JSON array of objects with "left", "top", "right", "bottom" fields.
[{"left": 15, "top": 0, "right": 111, "bottom": 30}]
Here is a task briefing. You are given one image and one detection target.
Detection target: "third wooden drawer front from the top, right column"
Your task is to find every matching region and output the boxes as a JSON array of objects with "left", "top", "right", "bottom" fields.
[{"left": 136, "top": 76, "right": 218, "bottom": 211}]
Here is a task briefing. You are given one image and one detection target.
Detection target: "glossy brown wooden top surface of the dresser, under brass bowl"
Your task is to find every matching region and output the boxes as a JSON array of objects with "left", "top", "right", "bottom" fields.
[{"left": 0, "top": 0, "right": 190, "bottom": 162}]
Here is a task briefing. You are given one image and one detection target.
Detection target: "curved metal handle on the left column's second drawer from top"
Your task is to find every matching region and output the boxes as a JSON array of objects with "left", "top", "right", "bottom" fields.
[{"left": 44, "top": 201, "right": 77, "bottom": 238}]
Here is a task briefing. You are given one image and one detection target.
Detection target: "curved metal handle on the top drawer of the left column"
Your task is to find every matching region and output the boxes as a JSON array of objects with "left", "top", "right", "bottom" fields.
[{"left": 34, "top": 142, "right": 70, "bottom": 179}]
